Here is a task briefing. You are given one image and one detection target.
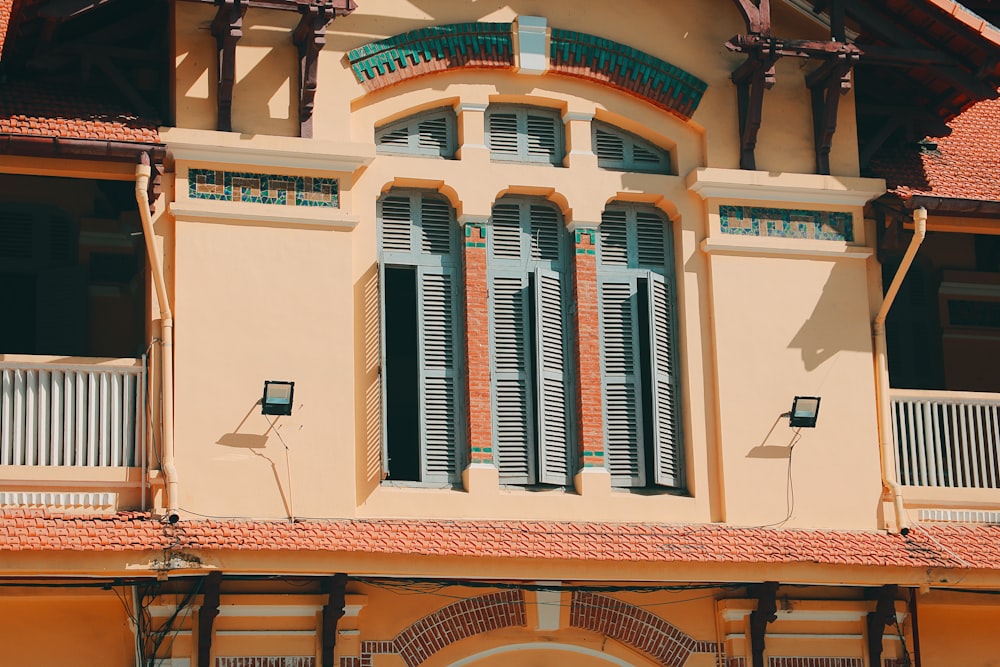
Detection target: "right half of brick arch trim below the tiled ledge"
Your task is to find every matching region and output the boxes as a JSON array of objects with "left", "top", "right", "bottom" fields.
[{"left": 570, "top": 591, "right": 719, "bottom": 667}]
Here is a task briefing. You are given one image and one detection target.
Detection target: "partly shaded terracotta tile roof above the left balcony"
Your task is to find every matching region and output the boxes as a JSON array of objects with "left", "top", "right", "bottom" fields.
[{"left": 0, "top": 81, "right": 158, "bottom": 143}]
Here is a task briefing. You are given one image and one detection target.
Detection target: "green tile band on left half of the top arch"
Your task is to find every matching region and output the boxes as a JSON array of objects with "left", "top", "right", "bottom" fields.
[{"left": 347, "top": 23, "right": 514, "bottom": 83}]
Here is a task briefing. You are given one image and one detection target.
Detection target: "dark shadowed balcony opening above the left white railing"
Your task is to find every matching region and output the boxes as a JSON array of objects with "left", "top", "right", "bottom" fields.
[{"left": 0, "top": 176, "right": 146, "bottom": 358}]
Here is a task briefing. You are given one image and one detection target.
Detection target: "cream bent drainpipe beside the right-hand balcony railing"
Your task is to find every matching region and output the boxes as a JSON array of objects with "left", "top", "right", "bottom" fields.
[{"left": 872, "top": 208, "right": 927, "bottom": 535}]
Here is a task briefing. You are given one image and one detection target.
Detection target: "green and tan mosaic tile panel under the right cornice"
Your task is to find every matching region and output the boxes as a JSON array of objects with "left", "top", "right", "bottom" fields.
[{"left": 719, "top": 206, "right": 854, "bottom": 242}]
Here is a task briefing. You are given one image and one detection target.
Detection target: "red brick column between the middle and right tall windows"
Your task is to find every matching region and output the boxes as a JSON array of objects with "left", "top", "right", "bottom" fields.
[{"left": 573, "top": 228, "right": 605, "bottom": 469}]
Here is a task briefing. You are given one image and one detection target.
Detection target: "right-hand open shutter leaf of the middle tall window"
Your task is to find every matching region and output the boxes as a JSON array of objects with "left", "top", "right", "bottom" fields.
[{"left": 535, "top": 269, "right": 571, "bottom": 485}]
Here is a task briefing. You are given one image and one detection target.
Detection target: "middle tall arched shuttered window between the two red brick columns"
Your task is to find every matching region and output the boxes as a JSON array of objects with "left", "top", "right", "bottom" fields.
[{"left": 487, "top": 197, "right": 574, "bottom": 485}]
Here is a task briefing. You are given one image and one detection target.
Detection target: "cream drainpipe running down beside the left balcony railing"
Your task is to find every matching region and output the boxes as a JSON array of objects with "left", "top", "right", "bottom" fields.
[{"left": 135, "top": 153, "right": 180, "bottom": 523}]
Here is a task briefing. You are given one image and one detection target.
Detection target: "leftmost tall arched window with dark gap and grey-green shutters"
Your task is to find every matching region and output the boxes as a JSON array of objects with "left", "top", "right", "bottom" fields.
[{"left": 378, "top": 190, "right": 464, "bottom": 483}]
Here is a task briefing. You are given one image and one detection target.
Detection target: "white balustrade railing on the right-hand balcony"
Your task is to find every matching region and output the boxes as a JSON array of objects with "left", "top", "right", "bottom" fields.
[{"left": 890, "top": 389, "right": 1000, "bottom": 489}]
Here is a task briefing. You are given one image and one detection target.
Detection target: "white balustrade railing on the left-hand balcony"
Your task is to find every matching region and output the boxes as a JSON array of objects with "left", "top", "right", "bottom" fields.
[{"left": 0, "top": 359, "right": 146, "bottom": 468}]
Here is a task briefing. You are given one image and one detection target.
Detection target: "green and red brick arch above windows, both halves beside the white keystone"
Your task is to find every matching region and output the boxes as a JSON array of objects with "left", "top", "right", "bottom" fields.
[{"left": 347, "top": 23, "right": 708, "bottom": 120}]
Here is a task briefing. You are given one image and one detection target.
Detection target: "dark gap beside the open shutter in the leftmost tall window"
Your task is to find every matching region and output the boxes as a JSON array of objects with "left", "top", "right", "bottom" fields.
[{"left": 384, "top": 267, "right": 420, "bottom": 482}]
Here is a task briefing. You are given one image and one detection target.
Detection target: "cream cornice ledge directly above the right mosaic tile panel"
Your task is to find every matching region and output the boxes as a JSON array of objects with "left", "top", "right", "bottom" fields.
[{"left": 687, "top": 167, "right": 885, "bottom": 206}]
